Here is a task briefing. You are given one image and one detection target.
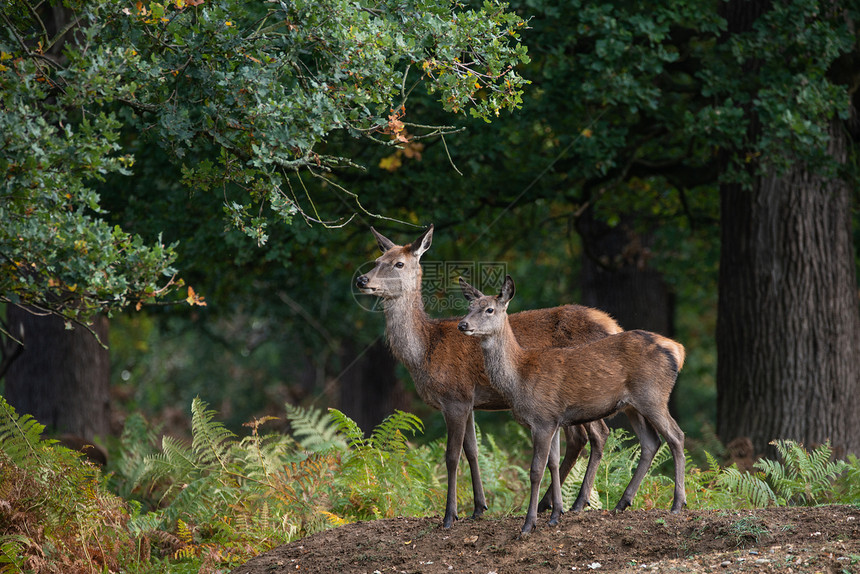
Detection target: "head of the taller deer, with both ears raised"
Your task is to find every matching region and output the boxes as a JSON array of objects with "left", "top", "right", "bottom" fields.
[{"left": 355, "top": 224, "right": 433, "bottom": 299}]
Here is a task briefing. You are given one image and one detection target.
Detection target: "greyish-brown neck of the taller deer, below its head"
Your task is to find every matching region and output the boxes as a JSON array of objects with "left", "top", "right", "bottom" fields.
[{"left": 384, "top": 289, "right": 430, "bottom": 371}]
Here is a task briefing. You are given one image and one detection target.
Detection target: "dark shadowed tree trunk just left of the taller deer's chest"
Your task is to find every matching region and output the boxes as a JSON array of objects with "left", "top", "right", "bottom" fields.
[{"left": 338, "top": 339, "right": 408, "bottom": 434}]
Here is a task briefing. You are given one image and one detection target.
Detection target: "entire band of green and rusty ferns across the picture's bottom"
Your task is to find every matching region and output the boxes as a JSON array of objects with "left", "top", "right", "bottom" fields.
[{"left": 0, "top": 398, "right": 860, "bottom": 573}]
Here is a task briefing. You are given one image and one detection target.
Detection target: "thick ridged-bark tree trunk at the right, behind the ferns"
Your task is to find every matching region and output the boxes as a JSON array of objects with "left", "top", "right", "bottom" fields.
[{"left": 717, "top": 121, "right": 860, "bottom": 460}]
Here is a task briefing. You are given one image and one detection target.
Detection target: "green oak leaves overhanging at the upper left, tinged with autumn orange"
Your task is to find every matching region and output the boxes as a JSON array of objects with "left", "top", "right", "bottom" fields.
[{"left": 0, "top": 0, "right": 528, "bottom": 321}]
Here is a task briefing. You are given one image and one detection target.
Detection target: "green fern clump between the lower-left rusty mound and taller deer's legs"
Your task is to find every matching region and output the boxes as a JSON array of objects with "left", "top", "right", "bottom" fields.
[{"left": 109, "top": 399, "right": 439, "bottom": 564}]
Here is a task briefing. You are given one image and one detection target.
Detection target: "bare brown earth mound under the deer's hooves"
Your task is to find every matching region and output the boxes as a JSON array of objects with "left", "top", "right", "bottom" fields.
[{"left": 231, "top": 506, "right": 860, "bottom": 574}]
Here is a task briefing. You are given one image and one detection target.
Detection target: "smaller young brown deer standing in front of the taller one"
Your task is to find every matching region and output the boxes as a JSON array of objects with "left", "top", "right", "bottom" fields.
[{"left": 458, "top": 276, "right": 686, "bottom": 535}]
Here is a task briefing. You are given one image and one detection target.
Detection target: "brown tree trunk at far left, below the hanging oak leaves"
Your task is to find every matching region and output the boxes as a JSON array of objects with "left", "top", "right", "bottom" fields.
[{"left": 5, "top": 305, "right": 110, "bottom": 441}]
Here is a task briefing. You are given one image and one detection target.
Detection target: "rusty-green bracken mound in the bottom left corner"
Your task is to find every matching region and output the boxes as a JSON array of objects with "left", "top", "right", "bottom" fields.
[{"left": 0, "top": 397, "right": 148, "bottom": 572}]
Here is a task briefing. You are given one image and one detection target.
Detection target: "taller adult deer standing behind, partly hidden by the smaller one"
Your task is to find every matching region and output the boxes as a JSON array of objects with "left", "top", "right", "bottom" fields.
[{"left": 356, "top": 225, "right": 621, "bottom": 528}]
